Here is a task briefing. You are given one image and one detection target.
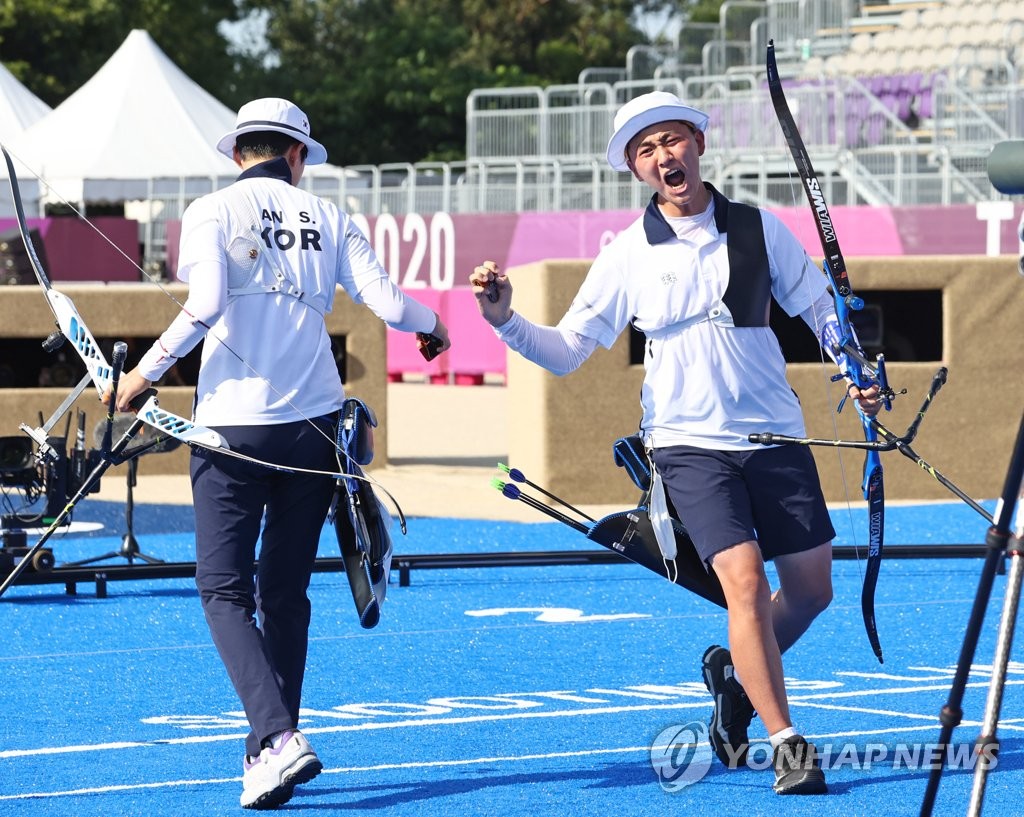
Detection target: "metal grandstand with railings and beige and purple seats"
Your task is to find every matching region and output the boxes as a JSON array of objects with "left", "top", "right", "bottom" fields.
[{"left": 136, "top": 0, "right": 1024, "bottom": 260}]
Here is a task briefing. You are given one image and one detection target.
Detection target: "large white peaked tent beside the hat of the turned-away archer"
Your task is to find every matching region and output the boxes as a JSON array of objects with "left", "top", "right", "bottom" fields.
[{"left": 12, "top": 29, "right": 352, "bottom": 207}]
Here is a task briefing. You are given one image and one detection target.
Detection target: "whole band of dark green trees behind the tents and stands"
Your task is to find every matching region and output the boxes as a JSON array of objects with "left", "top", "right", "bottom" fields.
[{"left": 0, "top": 0, "right": 704, "bottom": 165}]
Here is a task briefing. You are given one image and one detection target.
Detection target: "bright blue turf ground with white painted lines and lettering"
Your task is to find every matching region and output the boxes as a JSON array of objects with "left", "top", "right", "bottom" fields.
[{"left": 0, "top": 502, "right": 1024, "bottom": 817}]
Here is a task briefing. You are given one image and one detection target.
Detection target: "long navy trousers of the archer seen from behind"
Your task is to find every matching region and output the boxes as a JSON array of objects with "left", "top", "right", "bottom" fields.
[{"left": 190, "top": 415, "right": 337, "bottom": 756}]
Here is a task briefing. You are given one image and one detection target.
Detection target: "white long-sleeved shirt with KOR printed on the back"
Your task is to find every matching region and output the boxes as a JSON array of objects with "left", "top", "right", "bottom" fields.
[{"left": 139, "top": 160, "right": 436, "bottom": 426}]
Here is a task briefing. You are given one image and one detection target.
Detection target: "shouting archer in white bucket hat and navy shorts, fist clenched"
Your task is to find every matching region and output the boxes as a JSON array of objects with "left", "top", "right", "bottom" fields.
[{"left": 470, "top": 91, "right": 881, "bottom": 794}]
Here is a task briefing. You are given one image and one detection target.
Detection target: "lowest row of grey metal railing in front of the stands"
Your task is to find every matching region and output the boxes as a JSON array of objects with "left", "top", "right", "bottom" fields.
[{"left": 125, "top": 124, "right": 1004, "bottom": 268}]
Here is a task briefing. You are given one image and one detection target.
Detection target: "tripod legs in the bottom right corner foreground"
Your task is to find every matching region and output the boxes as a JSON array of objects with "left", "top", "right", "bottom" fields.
[{"left": 921, "top": 418, "right": 1024, "bottom": 817}]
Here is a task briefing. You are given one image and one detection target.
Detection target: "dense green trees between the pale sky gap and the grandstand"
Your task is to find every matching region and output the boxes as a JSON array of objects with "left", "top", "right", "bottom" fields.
[{"left": 234, "top": 0, "right": 665, "bottom": 164}]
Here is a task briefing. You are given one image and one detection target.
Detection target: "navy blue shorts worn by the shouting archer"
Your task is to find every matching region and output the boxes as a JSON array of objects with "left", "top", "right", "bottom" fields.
[{"left": 654, "top": 445, "right": 836, "bottom": 563}]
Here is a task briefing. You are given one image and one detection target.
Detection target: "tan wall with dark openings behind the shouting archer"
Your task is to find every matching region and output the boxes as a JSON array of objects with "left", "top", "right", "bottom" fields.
[{"left": 508, "top": 256, "right": 1024, "bottom": 504}]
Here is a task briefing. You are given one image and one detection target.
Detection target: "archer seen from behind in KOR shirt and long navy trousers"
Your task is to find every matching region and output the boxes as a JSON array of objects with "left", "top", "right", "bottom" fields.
[{"left": 110, "top": 98, "right": 451, "bottom": 809}]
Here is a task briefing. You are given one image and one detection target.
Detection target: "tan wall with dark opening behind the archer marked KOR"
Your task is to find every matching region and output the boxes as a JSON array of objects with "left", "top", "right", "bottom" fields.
[{"left": 0, "top": 284, "right": 387, "bottom": 474}]
